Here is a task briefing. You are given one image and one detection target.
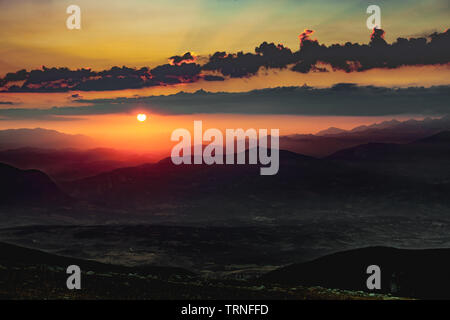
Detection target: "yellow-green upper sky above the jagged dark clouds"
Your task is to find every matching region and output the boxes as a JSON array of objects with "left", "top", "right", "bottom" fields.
[{"left": 0, "top": 0, "right": 450, "bottom": 74}]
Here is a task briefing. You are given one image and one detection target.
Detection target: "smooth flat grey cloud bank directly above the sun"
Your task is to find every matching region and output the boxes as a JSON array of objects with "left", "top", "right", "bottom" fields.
[{"left": 0, "top": 83, "right": 450, "bottom": 120}]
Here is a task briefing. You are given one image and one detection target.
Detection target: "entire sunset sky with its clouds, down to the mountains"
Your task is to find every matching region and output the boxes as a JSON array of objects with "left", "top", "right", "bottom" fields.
[{"left": 0, "top": 0, "right": 450, "bottom": 149}]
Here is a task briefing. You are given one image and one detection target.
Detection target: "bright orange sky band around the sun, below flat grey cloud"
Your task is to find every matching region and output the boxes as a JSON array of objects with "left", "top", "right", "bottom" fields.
[{"left": 0, "top": 113, "right": 432, "bottom": 156}]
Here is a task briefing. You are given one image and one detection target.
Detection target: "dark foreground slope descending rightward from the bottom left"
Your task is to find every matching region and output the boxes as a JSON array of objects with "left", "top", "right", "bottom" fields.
[{"left": 0, "top": 243, "right": 398, "bottom": 300}]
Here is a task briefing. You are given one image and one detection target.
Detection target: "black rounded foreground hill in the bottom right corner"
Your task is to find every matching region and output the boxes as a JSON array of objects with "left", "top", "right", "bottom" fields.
[{"left": 262, "top": 247, "right": 450, "bottom": 299}]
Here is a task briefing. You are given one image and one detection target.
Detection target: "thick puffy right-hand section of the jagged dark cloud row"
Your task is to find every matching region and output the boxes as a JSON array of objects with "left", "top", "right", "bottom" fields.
[{"left": 203, "top": 29, "right": 450, "bottom": 78}]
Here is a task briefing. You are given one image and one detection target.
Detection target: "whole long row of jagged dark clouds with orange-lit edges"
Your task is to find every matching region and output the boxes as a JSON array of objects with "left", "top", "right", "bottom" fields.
[{"left": 0, "top": 29, "right": 450, "bottom": 92}]
